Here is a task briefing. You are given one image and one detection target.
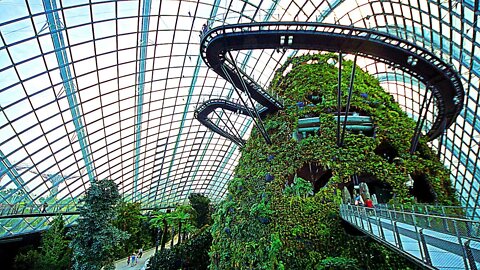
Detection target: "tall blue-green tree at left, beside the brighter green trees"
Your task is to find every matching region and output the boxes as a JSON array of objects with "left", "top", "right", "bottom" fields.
[{"left": 70, "top": 180, "right": 128, "bottom": 270}]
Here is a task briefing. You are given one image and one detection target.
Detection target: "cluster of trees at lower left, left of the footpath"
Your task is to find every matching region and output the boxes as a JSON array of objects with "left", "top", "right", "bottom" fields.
[{"left": 15, "top": 180, "right": 156, "bottom": 270}]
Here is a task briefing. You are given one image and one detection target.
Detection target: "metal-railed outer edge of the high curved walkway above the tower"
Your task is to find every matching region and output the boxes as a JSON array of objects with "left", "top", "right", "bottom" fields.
[{"left": 200, "top": 21, "right": 465, "bottom": 139}]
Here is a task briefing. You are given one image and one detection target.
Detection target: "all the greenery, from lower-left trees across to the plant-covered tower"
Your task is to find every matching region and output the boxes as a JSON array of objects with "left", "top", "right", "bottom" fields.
[{"left": 6, "top": 54, "right": 458, "bottom": 270}]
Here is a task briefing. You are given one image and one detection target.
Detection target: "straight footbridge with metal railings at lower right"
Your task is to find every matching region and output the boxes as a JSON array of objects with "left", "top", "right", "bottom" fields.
[{"left": 340, "top": 204, "right": 480, "bottom": 270}]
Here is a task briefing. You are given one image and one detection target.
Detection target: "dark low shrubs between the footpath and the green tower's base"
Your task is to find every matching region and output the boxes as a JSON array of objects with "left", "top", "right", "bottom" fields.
[{"left": 148, "top": 225, "right": 212, "bottom": 270}]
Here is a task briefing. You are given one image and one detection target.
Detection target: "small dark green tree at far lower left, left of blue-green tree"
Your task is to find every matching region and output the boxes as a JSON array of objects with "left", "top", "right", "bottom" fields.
[{"left": 15, "top": 216, "right": 72, "bottom": 270}]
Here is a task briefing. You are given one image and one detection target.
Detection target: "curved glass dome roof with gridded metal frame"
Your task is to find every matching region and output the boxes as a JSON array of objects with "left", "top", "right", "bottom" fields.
[{"left": 0, "top": 0, "right": 480, "bottom": 236}]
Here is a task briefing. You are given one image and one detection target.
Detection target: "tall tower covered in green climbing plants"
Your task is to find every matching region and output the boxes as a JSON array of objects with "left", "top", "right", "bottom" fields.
[{"left": 210, "top": 54, "right": 455, "bottom": 269}]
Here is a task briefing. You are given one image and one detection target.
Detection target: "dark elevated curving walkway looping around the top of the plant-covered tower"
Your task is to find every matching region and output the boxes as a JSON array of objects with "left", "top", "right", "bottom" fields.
[{"left": 196, "top": 22, "right": 465, "bottom": 143}]
